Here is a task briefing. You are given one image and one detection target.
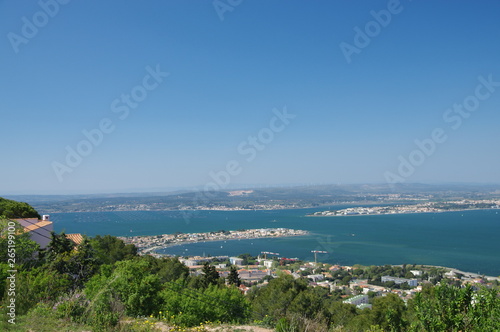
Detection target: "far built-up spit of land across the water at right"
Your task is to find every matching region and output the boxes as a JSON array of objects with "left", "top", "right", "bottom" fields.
[{"left": 308, "top": 199, "right": 500, "bottom": 217}]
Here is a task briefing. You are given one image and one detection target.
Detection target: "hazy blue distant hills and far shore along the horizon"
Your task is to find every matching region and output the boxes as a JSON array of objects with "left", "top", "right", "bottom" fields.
[{"left": 4, "top": 184, "right": 500, "bottom": 213}]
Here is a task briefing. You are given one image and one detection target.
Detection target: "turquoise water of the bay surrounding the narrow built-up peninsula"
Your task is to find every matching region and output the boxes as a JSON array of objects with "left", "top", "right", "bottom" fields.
[{"left": 51, "top": 206, "right": 500, "bottom": 276}]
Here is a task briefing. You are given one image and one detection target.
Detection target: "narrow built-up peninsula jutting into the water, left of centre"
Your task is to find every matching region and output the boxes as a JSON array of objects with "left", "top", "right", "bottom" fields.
[{"left": 119, "top": 228, "right": 308, "bottom": 253}]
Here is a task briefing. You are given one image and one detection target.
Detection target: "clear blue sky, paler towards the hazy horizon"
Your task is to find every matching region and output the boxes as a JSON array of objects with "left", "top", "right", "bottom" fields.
[{"left": 0, "top": 0, "right": 500, "bottom": 194}]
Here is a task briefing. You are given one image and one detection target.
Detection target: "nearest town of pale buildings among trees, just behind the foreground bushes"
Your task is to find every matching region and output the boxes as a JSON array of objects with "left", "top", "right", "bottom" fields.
[{"left": 144, "top": 253, "right": 500, "bottom": 309}]
